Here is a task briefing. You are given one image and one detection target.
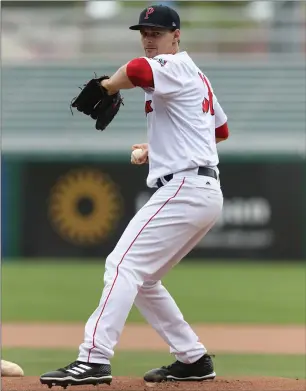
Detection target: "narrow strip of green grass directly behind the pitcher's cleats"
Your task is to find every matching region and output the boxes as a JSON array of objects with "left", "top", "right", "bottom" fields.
[{"left": 2, "top": 349, "right": 306, "bottom": 378}]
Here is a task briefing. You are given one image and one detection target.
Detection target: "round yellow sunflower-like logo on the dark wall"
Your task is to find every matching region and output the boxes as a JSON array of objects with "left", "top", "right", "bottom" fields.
[{"left": 48, "top": 168, "right": 122, "bottom": 245}]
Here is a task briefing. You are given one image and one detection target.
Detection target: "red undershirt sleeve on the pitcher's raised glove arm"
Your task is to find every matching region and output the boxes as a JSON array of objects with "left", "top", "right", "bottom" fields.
[{"left": 126, "top": 58, "right": 154, "bottom": 87}]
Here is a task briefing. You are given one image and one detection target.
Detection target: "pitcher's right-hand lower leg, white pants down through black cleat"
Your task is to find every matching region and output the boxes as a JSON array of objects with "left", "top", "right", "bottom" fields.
[{"left": 139, "top": 281, "right": 216, "bottom": 382}]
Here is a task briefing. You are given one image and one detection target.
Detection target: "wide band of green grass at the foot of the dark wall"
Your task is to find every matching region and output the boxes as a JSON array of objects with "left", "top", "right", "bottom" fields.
[{"left": 2, "top": 260, "right": 305, "bottom": 324}]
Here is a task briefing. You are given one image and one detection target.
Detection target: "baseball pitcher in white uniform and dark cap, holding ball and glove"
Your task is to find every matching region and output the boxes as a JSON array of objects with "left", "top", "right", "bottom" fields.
[{"left": 40, "top": 5, "right": 228, "bottom": 387}]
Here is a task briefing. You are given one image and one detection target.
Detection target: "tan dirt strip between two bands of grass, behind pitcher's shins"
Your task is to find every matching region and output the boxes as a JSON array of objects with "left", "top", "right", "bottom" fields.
[{"left": 1, "top": 323, "right": 306, "bottom": 354}]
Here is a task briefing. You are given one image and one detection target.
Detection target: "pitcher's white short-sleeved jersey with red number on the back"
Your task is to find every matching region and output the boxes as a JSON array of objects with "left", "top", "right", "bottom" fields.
[{"left": 144, "top": 52, "right": 227, "bottom": 187}]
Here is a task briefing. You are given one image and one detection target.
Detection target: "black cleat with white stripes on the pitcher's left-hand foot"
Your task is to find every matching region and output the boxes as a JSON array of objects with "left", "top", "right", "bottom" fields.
[{"left": 40, "top": 361, "right": 112, "bottom": 388}]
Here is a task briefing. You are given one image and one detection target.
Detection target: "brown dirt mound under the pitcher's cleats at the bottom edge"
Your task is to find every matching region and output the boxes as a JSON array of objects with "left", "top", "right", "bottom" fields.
[{"left": 1, "top": 377, "right": 306, "bottom": 391}]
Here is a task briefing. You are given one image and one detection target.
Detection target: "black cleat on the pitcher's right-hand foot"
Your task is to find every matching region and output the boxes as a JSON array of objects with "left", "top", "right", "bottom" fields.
[{"left": 144, "top": 354, "right": 216, "bottom": 383}]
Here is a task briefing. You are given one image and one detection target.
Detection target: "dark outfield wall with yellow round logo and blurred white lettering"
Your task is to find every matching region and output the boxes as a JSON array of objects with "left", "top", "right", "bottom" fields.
[{"left": 1, "top": 152, "right": 306, "bottom": 260}]
